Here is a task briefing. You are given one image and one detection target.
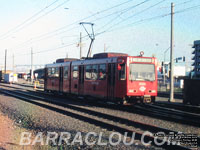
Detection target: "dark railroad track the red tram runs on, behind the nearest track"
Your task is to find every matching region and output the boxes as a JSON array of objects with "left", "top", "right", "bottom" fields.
[{"left": 0, "top": 84, "right": 200, "bottom": 127}]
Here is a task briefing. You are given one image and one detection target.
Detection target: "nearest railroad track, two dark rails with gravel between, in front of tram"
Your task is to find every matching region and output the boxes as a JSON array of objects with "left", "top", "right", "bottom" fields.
[{"left": 0, "top": 85, "right": 199, "bottom": 150}]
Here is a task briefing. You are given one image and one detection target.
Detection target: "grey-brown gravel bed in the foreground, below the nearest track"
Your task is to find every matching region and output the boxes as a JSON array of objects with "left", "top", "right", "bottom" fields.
[{"left": 0, "top": 94, "right": 161, "bottom": 149}]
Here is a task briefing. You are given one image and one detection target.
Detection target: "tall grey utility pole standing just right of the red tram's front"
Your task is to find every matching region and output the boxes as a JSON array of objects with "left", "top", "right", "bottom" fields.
[{"left": 169, "top": 3, "right": 174, "bottom": 102}]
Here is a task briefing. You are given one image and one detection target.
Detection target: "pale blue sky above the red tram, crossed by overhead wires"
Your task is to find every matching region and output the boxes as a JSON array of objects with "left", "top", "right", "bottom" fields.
[{"left": 0, "top": 0, "right": 200, "bottom": 68}]
